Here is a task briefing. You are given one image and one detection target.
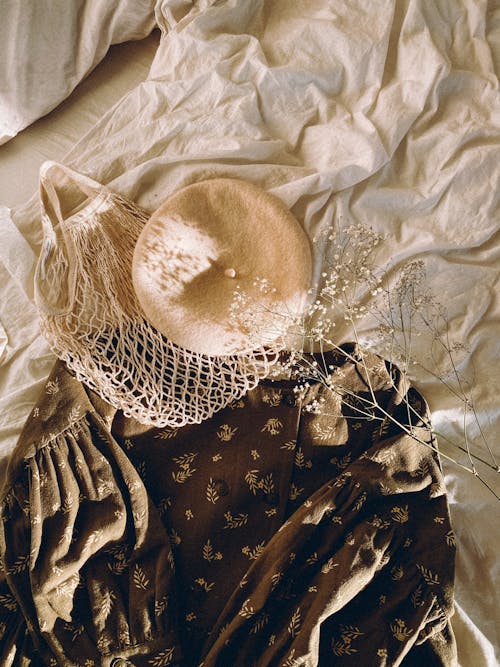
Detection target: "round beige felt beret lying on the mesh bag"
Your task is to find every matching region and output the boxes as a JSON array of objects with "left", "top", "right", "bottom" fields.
[{"left": 132, "top": 178, "right": 312, "bottom": 356}]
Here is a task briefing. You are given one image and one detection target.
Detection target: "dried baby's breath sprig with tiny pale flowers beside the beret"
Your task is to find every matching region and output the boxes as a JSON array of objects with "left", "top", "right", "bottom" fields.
[{"left": 233, "top": 224, "right": 500, "bottom": 499}]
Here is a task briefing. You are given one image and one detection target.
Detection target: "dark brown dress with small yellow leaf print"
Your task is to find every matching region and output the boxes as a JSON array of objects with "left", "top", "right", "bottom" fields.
[{"left": 0, "top": 347, "right": 456, "bottom": 667}]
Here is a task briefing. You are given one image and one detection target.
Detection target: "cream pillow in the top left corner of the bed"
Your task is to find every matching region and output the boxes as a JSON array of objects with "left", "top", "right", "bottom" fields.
[{"left": 0, "top": 0, "right": 155, "bottom": 144}]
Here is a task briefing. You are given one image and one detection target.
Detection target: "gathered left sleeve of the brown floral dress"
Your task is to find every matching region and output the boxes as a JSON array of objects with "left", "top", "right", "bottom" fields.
[{"left": 1, "top": 415, "right": 183, "bottom": 667}]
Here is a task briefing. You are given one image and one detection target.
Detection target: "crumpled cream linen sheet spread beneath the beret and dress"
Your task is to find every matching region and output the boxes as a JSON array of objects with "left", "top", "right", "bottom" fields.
[{"left": 0, "top": 0, "right": 500, "bottom": 667}]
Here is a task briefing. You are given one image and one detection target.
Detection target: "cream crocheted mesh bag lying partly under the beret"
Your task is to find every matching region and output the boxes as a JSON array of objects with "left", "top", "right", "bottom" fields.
[{"left": 35, "top": 163, "right": 279, "bottom": 427}]
